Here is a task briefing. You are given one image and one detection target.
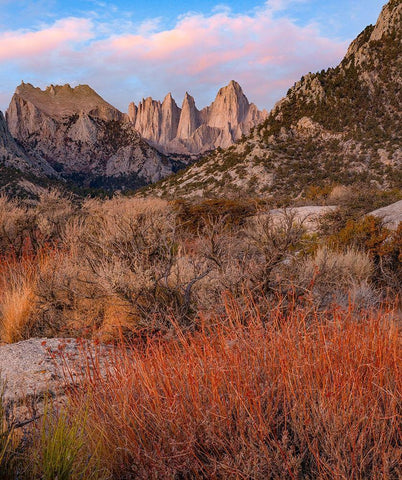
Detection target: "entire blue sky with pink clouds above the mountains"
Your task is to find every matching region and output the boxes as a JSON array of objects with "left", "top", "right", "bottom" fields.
[{"left": 0, "top": 0, "right": 385, "bottom": 111}]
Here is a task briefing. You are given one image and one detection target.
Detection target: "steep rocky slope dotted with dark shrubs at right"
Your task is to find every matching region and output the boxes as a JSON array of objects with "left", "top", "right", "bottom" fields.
[{"left": 150, "top": 0, "right": 402, "bottom": 199}]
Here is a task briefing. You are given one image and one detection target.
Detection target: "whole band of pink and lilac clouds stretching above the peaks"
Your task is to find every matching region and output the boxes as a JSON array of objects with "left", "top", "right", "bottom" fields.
[{"left": 0, "top": 4, "right": 347, "bottom": 108}]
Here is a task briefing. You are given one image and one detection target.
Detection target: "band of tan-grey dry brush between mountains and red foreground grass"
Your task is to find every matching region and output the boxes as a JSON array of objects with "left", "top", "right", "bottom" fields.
[{"left": 0, "top": 192, "right": 402, "bottom": 342}]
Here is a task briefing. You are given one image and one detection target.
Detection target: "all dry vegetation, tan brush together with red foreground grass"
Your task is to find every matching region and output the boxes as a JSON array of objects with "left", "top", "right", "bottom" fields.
[{"left": 0, "top": 192, "right": 402, "bottom": 480}]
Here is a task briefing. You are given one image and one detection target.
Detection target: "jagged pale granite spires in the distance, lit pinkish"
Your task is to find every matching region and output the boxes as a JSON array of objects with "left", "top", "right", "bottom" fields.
[{"left": 128, "top": 80, "right": 267, "bottom": 154}]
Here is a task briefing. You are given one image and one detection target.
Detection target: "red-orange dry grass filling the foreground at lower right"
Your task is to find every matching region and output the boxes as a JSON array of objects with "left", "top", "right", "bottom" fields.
[{"left": 61, "top": 301, "right": 402, "bottom": 480}]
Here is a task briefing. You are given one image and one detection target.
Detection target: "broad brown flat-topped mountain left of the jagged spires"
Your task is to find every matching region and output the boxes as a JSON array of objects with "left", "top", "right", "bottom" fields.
[{"left": 6, "top": 83, "right": 172, "bottom": 187}]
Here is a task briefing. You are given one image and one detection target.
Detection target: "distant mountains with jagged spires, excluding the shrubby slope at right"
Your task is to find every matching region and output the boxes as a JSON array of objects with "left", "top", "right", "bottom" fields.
[{"left": 0, "top": 81, "right": 267, "bottom": 194}]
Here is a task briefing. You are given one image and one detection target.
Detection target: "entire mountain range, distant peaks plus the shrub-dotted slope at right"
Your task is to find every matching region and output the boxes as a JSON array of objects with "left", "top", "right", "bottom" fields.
[{"left": 0, "top": 0, "right": 402, "bottom": 198}]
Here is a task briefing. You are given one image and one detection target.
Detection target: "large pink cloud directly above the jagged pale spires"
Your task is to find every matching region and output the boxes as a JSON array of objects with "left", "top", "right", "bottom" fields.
[{"left": 87, "top": 6, "right": 347, "bottom": 107}]
